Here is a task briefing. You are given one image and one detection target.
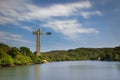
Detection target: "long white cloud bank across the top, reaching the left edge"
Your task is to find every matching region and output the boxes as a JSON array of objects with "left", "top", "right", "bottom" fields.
[{"left": 0, "top": 0, "right": 101, "bottom": 24}]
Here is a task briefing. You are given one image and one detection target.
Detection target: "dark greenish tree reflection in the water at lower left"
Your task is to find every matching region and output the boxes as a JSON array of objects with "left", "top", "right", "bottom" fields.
[{"left": 0, "top": 66, "right": 30, "bottom": 80}]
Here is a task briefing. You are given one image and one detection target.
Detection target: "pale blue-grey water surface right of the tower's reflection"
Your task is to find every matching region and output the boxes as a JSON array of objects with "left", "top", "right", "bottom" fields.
[{"left": 41, "top": 61, "right": 120, "bottom": 80}]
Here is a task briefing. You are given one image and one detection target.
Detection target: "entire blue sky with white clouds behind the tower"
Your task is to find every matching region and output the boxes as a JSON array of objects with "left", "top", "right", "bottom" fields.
[{"left": 0, "top": 0, "right": 120, "bottom": 52}]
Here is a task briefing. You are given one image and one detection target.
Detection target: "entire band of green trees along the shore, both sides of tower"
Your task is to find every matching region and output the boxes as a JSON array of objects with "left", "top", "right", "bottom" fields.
[{"left": 0, "top": 43, "right": 120, "bottom": 66}]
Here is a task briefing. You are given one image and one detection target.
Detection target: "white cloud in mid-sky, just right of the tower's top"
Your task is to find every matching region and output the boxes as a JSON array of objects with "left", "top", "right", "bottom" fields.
[{"left": 43, "top": 20, "right": 98, "bottom": 39}]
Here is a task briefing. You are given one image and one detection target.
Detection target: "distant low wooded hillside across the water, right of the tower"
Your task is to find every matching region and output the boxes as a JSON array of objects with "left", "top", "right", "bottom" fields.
[{"left": 41, "top": 46, "right": 120, "bottom": 61}]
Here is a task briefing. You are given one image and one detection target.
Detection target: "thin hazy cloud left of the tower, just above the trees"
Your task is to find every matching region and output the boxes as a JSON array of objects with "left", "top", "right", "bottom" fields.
[{"left": 0, "top": 31, "right": 33, "bottom": 44}]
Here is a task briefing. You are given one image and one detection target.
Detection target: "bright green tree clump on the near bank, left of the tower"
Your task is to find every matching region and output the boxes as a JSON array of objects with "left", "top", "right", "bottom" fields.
[{"left": 0, "top": 43, "right": 42, "bottom": 66}]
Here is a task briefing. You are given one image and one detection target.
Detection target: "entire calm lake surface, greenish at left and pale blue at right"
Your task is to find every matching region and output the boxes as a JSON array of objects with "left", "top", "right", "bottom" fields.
[{"left": 0, "top": 61, "right": 120, "bottom": 80}]
